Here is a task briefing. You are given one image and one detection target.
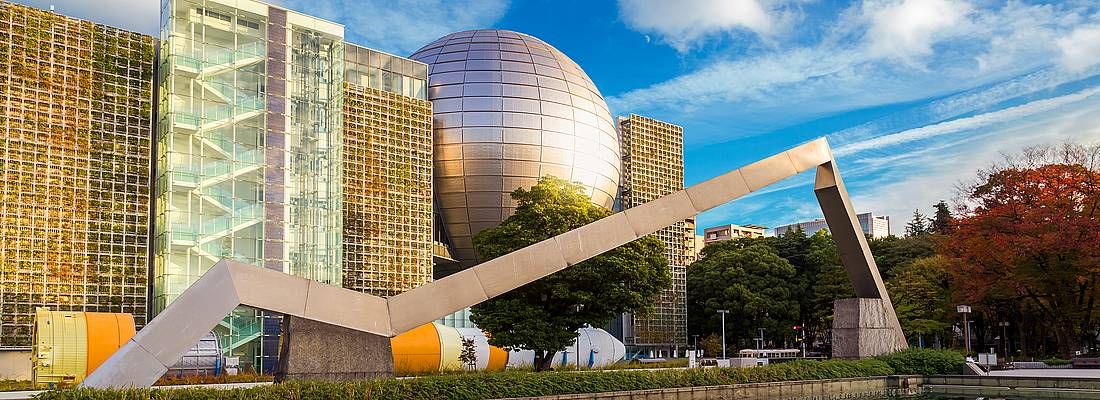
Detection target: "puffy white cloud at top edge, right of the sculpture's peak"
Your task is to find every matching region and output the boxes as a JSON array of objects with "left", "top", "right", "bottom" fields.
[{"left": 862, "top": 0, "right": 971, "bottom": 63}]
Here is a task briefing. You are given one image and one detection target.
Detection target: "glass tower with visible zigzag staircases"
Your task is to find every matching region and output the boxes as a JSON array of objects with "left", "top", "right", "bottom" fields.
[{"left": 151, "top": 0, "right": 344, "bottom": 370}]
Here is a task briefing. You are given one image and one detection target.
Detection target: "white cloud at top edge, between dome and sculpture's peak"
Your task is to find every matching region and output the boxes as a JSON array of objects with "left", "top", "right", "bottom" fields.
[{"left": 618, "top": 0, "right": 779, "bottom": 52}]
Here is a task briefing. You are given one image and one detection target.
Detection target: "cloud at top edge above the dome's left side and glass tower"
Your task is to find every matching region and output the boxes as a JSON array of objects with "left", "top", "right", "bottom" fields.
[{"left": 275, "top": 0, "right": 508, "bottom": 55}]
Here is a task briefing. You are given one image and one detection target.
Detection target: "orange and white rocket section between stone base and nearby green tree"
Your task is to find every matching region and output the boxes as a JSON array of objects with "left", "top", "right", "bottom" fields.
[{"left": 389, "top": 322, "right": 508, "bottom": 375}]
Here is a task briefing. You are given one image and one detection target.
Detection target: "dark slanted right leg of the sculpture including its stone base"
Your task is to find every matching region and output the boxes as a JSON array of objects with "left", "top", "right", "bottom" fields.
[{"left": 814, "top": 162, "right": 908, "bottom": 358}]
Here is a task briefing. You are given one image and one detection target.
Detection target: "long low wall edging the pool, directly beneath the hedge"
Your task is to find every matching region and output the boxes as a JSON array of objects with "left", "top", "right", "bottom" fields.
[{"left": 497, "top": 373, "right": 921, "bottom": 400}]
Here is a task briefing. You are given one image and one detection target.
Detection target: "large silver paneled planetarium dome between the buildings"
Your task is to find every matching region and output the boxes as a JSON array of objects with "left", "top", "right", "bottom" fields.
[{"left": 410, "top": 30, "right": 620, "bottom": 266}]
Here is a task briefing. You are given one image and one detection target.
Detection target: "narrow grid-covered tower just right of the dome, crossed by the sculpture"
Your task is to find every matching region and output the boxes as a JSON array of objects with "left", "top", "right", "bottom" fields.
[{"left": 618, "top": 114, "right": 695, "bottom": 356}]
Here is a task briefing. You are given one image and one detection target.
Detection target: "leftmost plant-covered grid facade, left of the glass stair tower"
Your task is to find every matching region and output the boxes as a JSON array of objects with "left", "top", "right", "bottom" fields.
[{"left": 0, "top": 1, "right": 154, "bottom": 347}]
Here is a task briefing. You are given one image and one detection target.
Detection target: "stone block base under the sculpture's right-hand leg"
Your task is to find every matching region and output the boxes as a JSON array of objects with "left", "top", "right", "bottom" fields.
[{"left": 833, "top": 299, "right": 905, "bottom": 359}]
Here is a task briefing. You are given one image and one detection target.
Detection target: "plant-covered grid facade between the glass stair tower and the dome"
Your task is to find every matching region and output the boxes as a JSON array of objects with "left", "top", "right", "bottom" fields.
[{"left": 343, "top": 44, "right": 433, "bottom": 296}]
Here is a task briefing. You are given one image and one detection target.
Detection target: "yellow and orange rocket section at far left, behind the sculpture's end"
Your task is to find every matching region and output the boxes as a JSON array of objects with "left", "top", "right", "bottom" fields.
[{"left": 31, "top": 308, "right": 134, "bottom": 385}]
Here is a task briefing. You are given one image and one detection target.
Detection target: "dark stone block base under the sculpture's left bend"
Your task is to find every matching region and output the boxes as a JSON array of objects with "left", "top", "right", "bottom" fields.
[{"left": 275, "top": 315, "right": 394, "bottom": 381}]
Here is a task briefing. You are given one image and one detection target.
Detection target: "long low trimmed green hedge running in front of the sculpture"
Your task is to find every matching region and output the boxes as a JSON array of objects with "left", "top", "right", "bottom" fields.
[{"left": 39, "top": 351, "right": 963, "bottom": 400}]
